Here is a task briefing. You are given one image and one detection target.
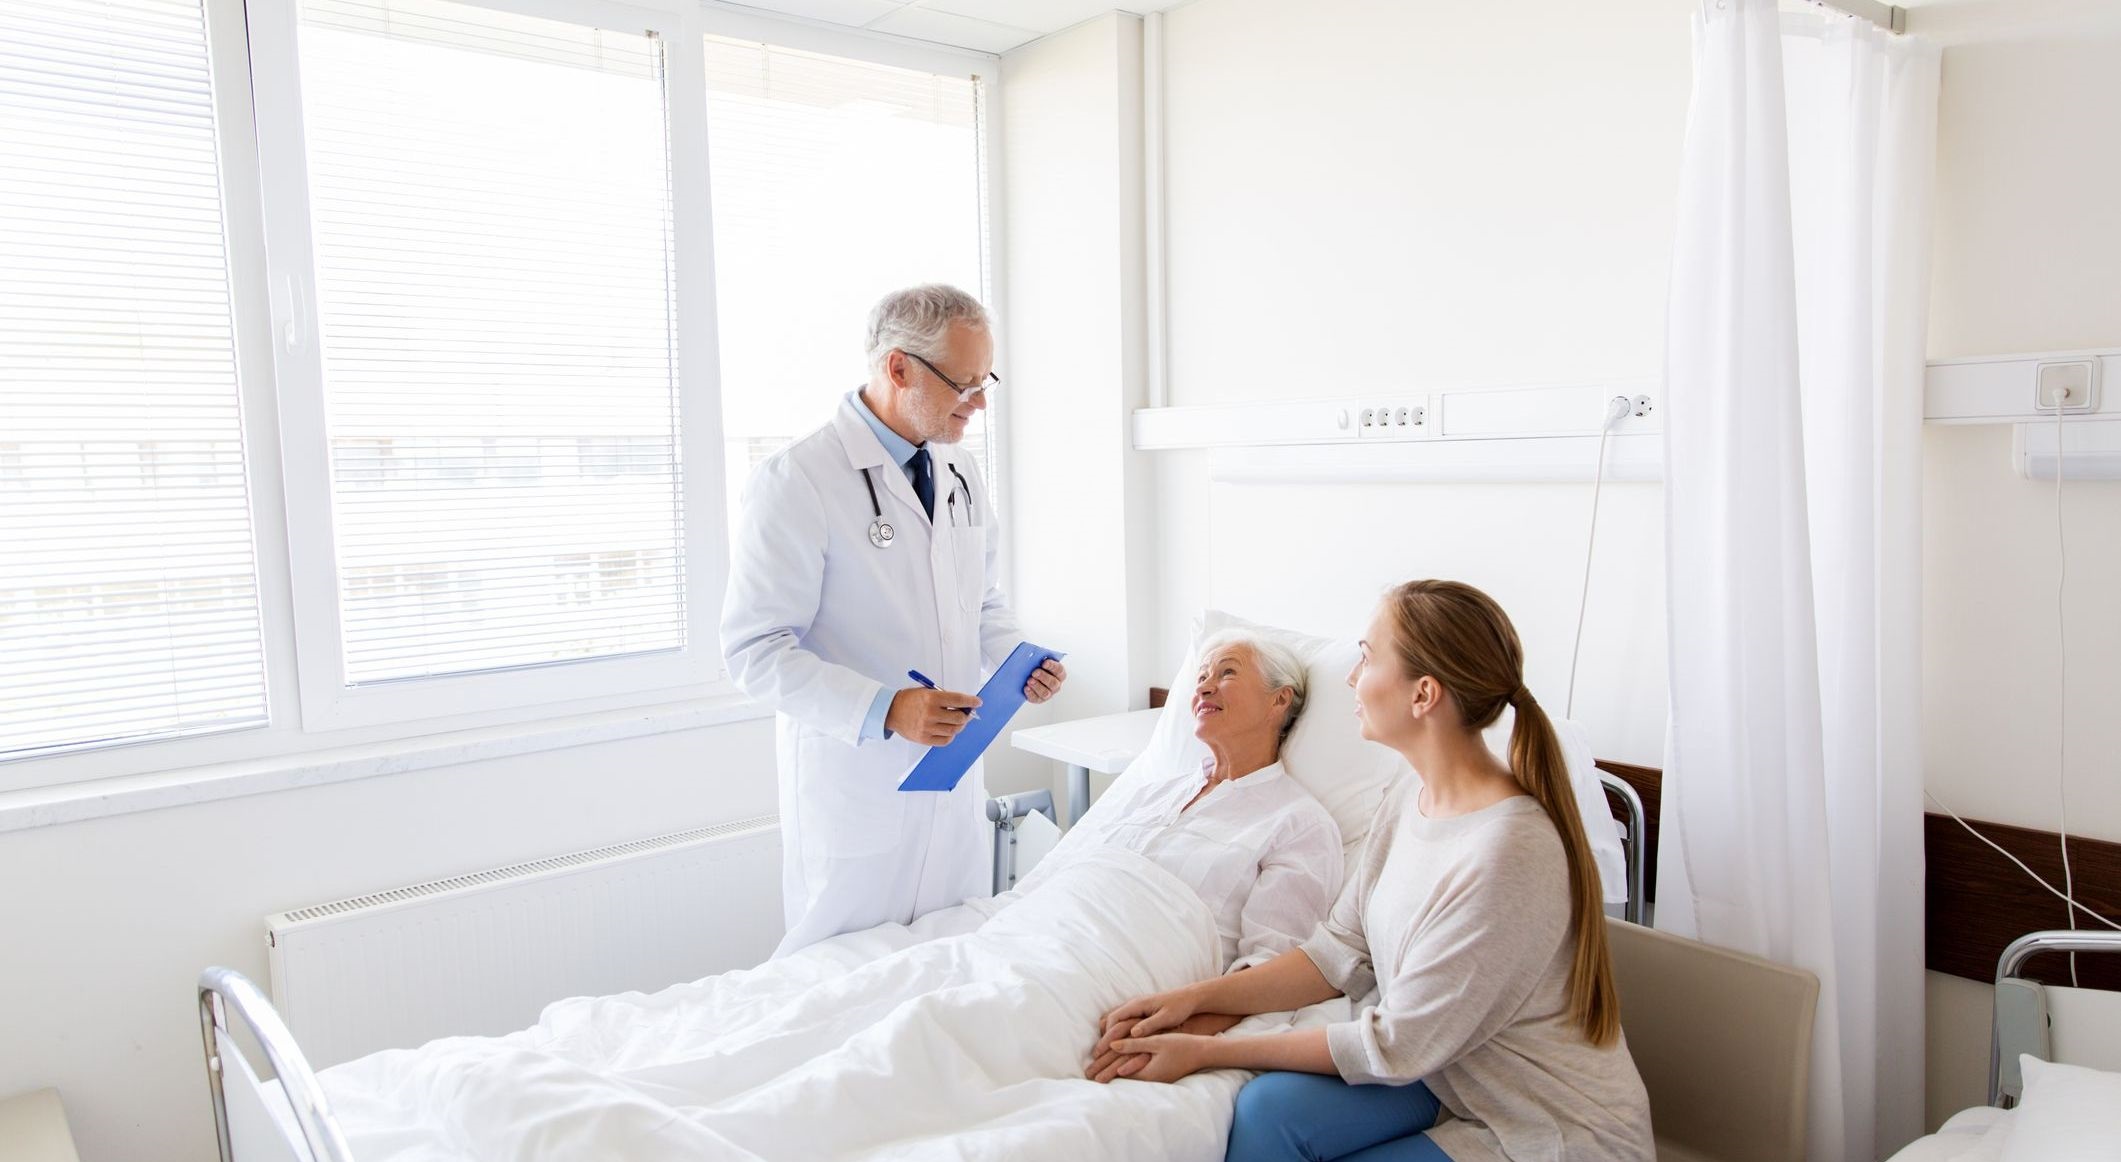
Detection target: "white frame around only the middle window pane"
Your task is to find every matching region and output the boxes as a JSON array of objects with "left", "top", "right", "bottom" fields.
[{"left": 250, "top": 0, "right": 728, "bottom": 729}]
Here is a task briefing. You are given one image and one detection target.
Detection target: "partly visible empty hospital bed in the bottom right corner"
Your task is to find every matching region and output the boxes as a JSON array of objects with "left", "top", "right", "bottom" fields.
[{"left": 1890, "top": 931, "right": 2121, "bottom": 1162}]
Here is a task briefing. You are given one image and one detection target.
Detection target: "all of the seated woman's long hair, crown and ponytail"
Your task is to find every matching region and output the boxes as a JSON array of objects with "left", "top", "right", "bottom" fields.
[{"left": 1385, "top": 581, "right": 1620, "bottom": 1045}]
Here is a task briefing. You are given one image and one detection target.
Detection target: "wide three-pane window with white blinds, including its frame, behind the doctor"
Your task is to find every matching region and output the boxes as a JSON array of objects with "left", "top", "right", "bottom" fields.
[{"left": 0, "top": 0, "right": 986, "bottom": 789}]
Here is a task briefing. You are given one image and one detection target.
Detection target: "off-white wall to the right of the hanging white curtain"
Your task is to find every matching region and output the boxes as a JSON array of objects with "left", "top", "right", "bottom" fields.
[{"left": 1909, "top": 0, "right": 2121, "bottom": 1124}]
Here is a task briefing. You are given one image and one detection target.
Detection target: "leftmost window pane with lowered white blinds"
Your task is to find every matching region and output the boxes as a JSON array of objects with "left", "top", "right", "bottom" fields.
[{"left": 0, "top": 0, "right": 265, "bottom": 757}]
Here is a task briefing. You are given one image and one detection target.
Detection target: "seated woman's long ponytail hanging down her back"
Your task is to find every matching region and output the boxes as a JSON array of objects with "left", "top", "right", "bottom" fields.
[{"left": 1510, "top": 687, "right": 1620, "bottom": 1045}]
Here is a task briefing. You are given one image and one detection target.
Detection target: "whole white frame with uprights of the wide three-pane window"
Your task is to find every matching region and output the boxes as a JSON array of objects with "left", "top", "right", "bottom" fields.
[{"left": 0, "top": 0, "right": 1012, "bottom": 797}]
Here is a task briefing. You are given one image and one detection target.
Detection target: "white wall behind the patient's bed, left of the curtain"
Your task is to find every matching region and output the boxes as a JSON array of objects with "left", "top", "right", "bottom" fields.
[{"left": 1156, "top": 0, "right": 1690, "bottom": 763}]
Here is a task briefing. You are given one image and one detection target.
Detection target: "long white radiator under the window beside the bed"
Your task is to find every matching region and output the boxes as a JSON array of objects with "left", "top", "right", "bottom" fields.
[{"left": 265, "top": 816, "right": 783, "bottom": 1069}]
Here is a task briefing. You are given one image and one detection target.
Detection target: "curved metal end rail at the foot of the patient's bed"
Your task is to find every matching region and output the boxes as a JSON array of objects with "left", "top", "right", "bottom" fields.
[{"left": 199, "top": 967, "right": 354, "bottom": 1162}]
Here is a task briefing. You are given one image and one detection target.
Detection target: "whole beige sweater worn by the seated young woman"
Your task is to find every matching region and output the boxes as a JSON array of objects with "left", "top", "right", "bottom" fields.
[{"left": 1302, "top": 778, "right": 1657, "bottom": 1162}]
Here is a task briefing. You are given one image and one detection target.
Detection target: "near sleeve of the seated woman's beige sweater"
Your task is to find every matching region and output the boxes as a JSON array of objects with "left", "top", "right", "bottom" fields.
[{"left": 1307, "top": 827, "right": 1570, "bottom": 1086}]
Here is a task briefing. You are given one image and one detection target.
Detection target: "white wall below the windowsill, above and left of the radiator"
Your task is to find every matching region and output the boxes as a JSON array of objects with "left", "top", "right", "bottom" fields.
[{"left": 0, "top": 721, "right": 774, "bottom": 1162}]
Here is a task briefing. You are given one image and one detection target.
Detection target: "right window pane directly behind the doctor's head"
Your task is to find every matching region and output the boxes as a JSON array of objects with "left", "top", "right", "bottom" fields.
[{"left": 706, "top": 36, "right": 993, "bottom": 528}]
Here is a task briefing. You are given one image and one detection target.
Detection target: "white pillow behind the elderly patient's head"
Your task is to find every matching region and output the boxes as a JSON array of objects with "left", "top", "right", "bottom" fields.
[{"left": 1120, "top": 609, "right": 1627, "bottom": 903}]
